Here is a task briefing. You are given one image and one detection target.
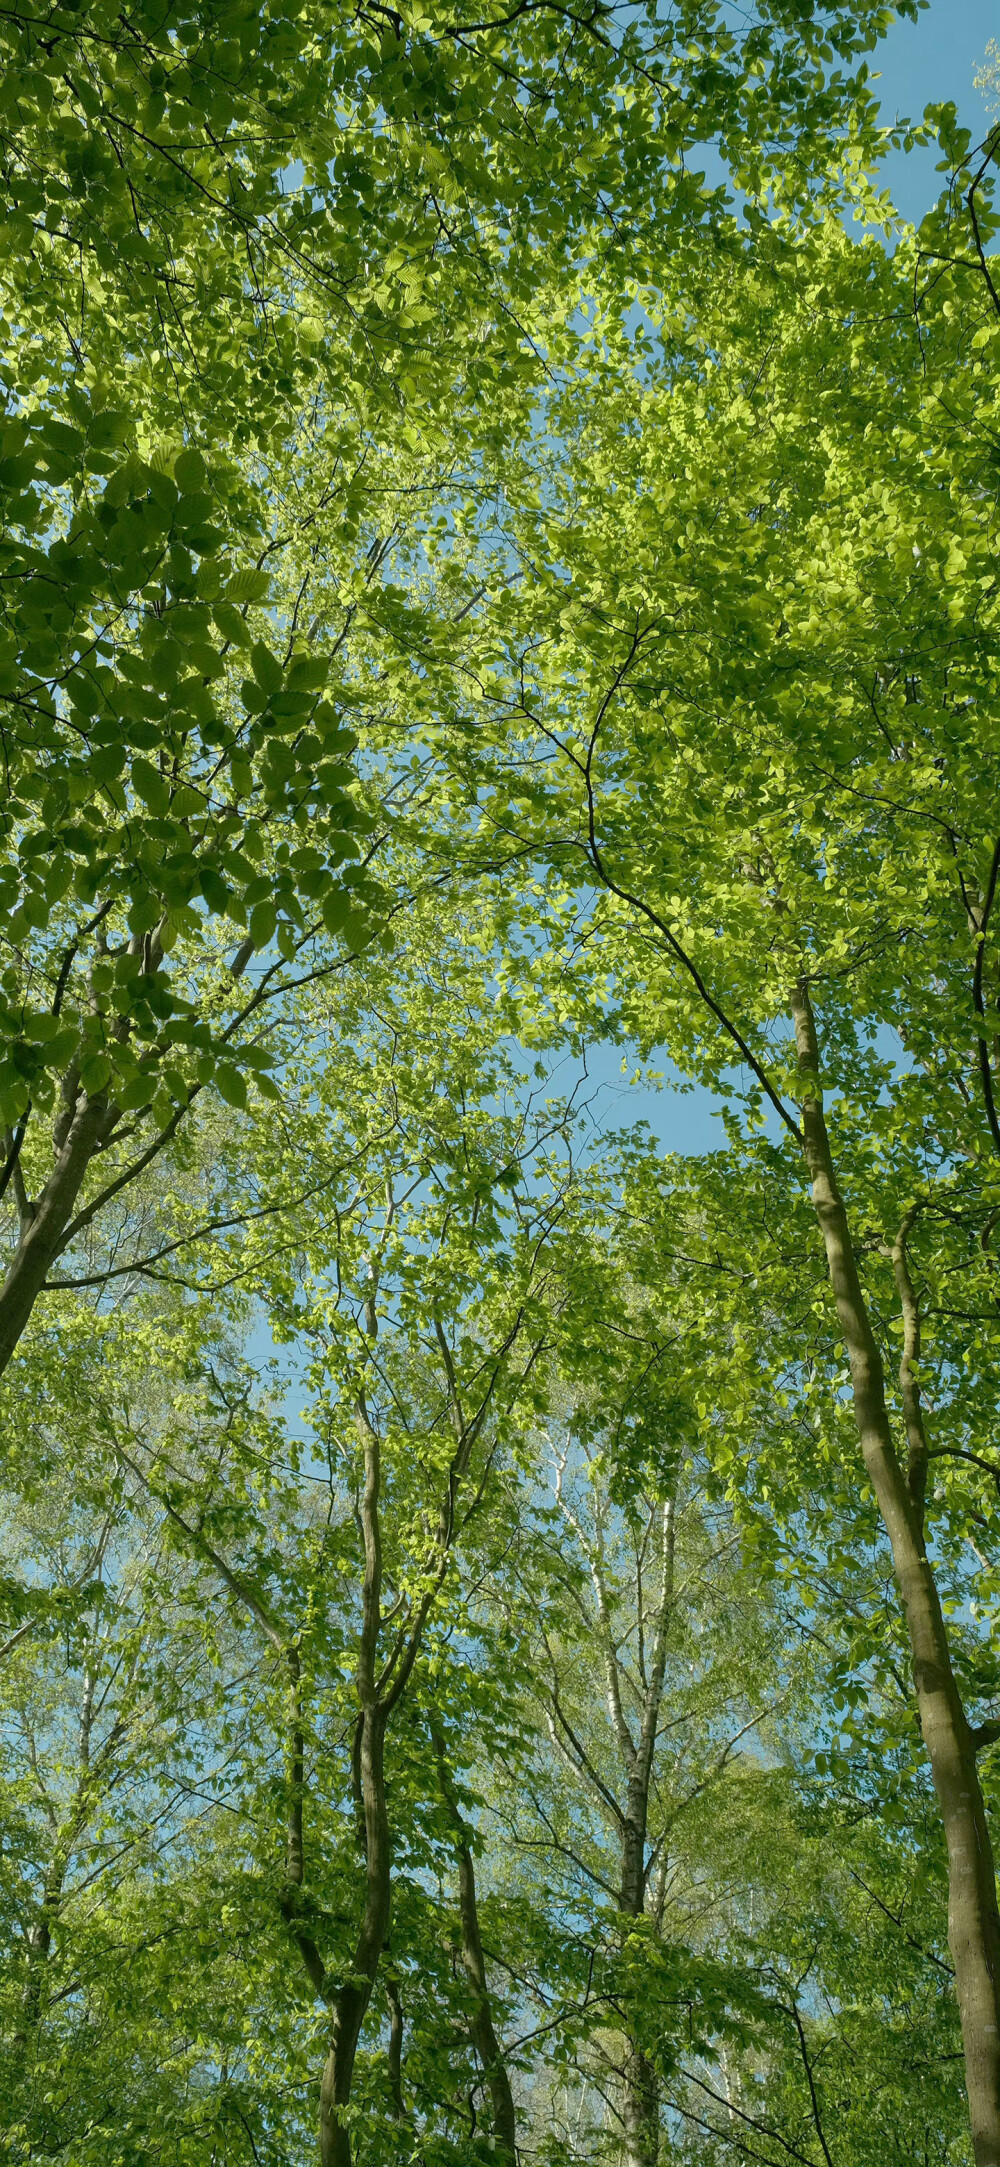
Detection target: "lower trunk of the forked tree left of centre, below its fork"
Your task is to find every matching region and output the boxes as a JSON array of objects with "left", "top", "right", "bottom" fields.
[{"left": 319, "top": 1708, "right": 393, "bottom": 2167}]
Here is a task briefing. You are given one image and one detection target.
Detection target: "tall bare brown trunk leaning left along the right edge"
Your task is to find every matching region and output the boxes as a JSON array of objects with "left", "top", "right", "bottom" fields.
[{"left": 792, "top": 984, "right": 1000, "bottom": 2167}]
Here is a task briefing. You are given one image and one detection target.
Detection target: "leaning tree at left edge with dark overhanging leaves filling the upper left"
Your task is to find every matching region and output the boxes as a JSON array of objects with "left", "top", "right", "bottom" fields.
[{"left": 0, "top": 0, "right": 924, "bottom": 1363}]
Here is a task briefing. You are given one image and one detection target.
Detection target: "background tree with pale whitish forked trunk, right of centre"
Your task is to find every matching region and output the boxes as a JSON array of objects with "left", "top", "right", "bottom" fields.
[{"left": 455, "top": 1213, "right": 965, "bottom": 2167}]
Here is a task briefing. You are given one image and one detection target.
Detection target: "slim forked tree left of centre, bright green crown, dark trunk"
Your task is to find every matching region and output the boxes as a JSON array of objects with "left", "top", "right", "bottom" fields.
[{"left": 0, "top": 888, "right": 659, "bottom": 2160}]
